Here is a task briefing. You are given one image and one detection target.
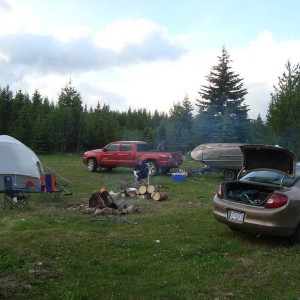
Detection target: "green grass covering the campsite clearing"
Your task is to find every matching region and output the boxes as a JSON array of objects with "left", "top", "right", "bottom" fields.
[{"left": 0, "top": 155, "right": 300, "bottom": 299}]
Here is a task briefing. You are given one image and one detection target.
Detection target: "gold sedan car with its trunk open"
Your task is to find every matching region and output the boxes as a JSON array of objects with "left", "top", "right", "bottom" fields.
[{"left": 213, "top": 145, "right": 300, "bottom": 243}]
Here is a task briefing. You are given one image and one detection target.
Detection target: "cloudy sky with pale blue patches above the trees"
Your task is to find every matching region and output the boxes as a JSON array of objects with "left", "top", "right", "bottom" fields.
[{"left": 0, "top": 0, "right": 300, "bottom": 118}]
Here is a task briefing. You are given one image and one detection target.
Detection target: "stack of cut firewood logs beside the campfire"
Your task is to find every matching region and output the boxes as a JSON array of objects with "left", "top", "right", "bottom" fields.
[{"left": 120, "top": 181, "right": 168, "bottom": 201}]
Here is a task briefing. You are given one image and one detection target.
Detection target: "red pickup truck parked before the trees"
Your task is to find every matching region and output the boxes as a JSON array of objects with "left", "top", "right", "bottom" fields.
[{"left": 82, "top": 141, "right": 183, "bottom": 175}]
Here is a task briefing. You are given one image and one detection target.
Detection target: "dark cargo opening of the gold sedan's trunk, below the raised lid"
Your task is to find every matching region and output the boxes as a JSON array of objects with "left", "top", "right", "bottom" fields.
[{"left": 222, "top": 182, "right": 280, "bottom": 206}]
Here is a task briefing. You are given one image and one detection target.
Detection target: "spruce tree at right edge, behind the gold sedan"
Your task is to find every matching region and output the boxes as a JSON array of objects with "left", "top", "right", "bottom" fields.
[{"left": 267, "top": 61, "right": 300, "bottom": 155}]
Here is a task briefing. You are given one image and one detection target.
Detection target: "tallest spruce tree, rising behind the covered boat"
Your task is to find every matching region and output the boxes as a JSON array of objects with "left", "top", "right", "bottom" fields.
[{"left": 196, "top": 47, "right": 249, "bottom": 142}]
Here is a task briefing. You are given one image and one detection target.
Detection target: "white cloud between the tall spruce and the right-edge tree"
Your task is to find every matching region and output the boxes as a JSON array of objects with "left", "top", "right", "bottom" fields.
[{"left": 230, "top": 31, "right": 300, "bottom": 118}]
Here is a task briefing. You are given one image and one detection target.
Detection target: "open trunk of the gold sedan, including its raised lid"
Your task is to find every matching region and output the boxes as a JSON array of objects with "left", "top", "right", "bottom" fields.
[{"left": 222, "top": 145, "right": 296, "bottom": 206}]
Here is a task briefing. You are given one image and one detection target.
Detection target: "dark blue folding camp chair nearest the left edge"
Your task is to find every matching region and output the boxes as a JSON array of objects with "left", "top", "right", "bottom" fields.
[{"left": 3, "top": 176, "right": 30, "bottom": 211}]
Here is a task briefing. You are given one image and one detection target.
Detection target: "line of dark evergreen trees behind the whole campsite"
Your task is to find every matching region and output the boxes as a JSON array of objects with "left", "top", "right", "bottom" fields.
[{"left": 0, "top": 48, "right": 300, "bottom": 156}]
